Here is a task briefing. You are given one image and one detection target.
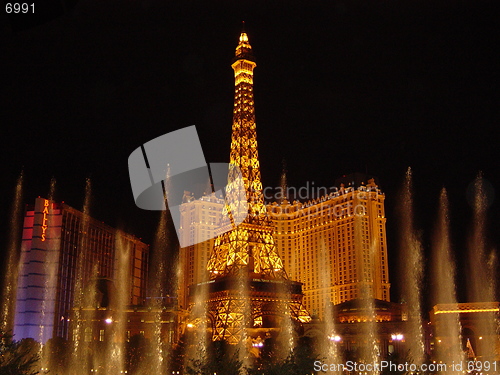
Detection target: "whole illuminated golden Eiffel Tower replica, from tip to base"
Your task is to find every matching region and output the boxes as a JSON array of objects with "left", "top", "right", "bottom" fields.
[{"left": 191, "top": 27, "right": 311, "bottom": 344}]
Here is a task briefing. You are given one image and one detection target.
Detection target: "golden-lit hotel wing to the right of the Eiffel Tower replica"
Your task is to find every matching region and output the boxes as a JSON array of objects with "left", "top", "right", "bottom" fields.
[{"left": 268, "top": 174, "right": 390, "bottom": 319}]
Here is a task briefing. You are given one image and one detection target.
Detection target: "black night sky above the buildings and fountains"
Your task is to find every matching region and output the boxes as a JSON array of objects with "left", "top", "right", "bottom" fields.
[{"left": 0, "top": 0, "right": 500, "bottom": 310}]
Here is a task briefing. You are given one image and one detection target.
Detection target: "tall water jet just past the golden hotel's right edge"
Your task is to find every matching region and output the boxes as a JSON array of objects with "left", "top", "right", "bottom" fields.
[{"left": 399, "top": 168, "right": 424, "bottom": 366}]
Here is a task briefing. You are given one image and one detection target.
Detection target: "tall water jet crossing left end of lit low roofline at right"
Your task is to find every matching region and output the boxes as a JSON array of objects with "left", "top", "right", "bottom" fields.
[{"left": 431, "top": 188, "right": 465, "bottom": 372}]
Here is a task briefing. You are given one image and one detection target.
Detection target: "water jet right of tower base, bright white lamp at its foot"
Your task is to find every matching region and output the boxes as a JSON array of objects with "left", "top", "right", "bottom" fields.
[{"left": 318, "top": 237, "right": 343, "bottom": 374}]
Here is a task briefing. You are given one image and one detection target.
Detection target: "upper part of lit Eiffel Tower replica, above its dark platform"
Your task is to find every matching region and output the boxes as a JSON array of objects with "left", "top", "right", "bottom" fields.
[{"left": 208, "top": 28, "right": 287, "bottom": 279}]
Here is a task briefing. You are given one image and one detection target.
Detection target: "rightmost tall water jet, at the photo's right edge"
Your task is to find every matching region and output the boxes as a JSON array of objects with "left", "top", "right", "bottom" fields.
[{"left": 467, "top": 173, "right": 499, "bottom": 360}]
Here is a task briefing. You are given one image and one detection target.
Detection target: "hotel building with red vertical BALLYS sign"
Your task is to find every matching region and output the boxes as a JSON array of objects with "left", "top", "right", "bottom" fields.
[{"left": 14, "top": 198, "right": 149, "bottom": 343}]
